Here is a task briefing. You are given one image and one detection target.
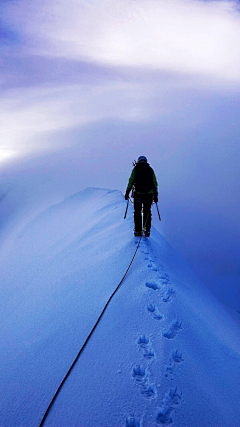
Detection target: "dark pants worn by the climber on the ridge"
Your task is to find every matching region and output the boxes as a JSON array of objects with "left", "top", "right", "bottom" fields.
[{"left": 134, "top": 194, "right": 153, "bottom": 232}]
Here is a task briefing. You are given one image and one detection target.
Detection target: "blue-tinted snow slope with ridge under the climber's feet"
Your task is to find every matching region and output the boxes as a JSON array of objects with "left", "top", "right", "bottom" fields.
[{"left": 0, "top": 188, "right": 240, "bottom": 427}]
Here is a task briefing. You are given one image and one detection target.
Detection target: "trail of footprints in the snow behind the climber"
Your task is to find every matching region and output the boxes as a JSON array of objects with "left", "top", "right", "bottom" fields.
[{"left": 126, "top": 240, "right": 184, "bottom": 427}]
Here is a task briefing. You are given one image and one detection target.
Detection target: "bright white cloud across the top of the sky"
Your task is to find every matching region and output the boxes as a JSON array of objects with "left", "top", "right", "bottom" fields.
[{"left": 4, "top": 0, "right": 240, "bottom": 81}]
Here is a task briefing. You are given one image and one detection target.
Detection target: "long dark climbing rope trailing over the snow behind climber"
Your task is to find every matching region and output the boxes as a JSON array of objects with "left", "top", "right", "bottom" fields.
[{"left": 39, "top": 222, "right": 145, "bottom": 427}]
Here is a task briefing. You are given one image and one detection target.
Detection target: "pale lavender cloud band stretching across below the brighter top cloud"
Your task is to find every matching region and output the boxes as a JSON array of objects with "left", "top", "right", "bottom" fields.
[{"left": 0, "top": 71, "right": 239, "bottom": 160}]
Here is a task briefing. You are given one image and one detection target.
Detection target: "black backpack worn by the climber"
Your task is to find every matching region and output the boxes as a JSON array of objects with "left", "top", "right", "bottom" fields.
[{"left": 134, "top": 162, "right": 154, "bottom": 193}]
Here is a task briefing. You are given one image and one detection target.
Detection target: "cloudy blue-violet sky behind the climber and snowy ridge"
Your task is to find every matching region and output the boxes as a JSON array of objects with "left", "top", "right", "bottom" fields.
[{"left": 0, "top": 0, "right": 240, "bottom": 308}]
